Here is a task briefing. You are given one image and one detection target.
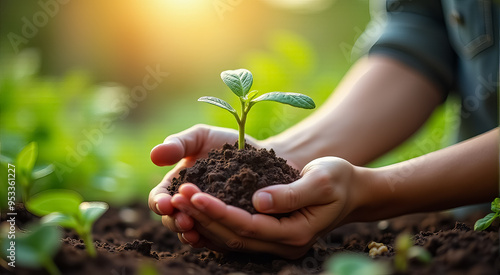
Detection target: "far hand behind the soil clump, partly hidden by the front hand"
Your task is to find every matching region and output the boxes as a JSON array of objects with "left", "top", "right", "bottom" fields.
[{"left": 148, "top": 125, "right": 262, "bottom": 246}]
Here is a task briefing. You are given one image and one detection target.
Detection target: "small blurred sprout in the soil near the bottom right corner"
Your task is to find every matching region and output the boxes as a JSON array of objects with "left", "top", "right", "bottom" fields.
[{"left": 394, "top": 233, "right": 432, "bottom": 272}]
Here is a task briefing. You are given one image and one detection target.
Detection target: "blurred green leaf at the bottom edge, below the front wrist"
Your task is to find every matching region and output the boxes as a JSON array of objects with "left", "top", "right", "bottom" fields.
[{"left": 325, "top": 253, "right": 389, "bottom": 275}]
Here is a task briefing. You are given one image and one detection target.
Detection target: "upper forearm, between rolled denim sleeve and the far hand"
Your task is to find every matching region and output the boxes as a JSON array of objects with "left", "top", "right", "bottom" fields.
[{"left": 266, "top": 57, "right": 441, "bottom": 167}]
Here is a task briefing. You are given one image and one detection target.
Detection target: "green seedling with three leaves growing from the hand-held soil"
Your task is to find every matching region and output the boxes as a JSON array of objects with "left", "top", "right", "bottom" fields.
[{"left": 198, "top": 69, "right": 316, "bottom": 149}]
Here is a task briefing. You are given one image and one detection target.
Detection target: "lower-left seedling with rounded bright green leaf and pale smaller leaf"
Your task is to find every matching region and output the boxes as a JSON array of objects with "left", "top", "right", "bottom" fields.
[{"left": 27, "top": 189, "right": 109, "bottom": 257}]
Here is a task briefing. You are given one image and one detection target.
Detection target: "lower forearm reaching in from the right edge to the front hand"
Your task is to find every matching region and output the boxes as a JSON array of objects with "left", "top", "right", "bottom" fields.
[{"left": 350, "top": 128, "right": 499, "bottom": 221}]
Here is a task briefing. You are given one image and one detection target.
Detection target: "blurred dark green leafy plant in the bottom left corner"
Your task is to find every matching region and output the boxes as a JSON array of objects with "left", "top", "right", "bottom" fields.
[{"left": 1, "top": 225, "right": 62, "bottom": 275}]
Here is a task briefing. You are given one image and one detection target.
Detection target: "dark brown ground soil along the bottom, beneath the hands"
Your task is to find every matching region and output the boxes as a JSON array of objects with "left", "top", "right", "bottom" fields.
[{"left": 0, "top": 203, "right": 500, "bottom": 275}]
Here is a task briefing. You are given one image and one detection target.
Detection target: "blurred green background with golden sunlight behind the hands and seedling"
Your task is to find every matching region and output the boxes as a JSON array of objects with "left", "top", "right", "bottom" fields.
[{"left": 0, "top": 0, "right": 456, "bottom": 207}]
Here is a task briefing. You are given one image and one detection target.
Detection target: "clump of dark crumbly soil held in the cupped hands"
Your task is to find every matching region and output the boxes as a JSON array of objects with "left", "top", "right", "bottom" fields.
[{"left": 168, "top": 144, "right": 300, "bottom": 214}]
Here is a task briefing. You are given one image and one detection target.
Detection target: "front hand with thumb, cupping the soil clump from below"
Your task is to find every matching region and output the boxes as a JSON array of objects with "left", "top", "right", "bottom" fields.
[{"left": 171, "top": 157, "right": 363, "bottom": 259}]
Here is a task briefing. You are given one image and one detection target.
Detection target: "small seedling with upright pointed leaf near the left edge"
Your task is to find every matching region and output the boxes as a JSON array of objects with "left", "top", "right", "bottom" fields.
[{"left": 16, "top": 142, "right": 54, "bottom": 203}]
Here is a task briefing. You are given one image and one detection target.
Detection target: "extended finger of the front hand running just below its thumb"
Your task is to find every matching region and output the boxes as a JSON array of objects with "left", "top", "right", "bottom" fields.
[{"left": 190, "top": 193, "right": 313, "bottom": 246}]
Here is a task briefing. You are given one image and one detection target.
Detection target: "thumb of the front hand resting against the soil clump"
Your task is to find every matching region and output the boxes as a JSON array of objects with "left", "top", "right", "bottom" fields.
[{"left": 252, "top": 164, "right": 334, "bottom": 213}]
